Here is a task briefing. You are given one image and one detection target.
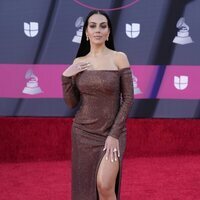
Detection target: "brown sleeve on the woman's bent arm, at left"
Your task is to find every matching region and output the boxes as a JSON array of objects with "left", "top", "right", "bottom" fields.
[{"left": 62, "top": 75, "right": 80, "bottom": 108}]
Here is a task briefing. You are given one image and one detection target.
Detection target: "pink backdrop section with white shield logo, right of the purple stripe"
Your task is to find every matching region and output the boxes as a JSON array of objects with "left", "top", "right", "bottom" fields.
[{"left": 157, "top": 65, "right": 200, "bottom": 99}]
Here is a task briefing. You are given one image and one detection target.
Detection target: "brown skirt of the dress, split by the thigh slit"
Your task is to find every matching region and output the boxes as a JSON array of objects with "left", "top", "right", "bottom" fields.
[{"left": 72, "top": 127, "right": 126, "bottom": 200}]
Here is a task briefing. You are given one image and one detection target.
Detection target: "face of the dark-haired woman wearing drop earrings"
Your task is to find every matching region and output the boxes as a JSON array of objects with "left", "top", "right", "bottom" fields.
[{"left": 86, "top": 14, "right": 110, "bottom": 44}]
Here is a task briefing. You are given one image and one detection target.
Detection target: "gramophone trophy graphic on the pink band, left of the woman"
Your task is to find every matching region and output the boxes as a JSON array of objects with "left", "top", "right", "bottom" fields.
[{"left": 22, "top": 69, "right": 43, "bottom": 95}]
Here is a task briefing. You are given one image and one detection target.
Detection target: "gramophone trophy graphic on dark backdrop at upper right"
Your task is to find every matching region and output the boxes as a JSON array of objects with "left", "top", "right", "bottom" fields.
[{"left": 173, "top": 17, "right": 193, "bottom": 45}]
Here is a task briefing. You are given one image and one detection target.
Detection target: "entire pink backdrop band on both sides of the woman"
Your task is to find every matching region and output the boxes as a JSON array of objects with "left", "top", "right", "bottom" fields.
[{"left": 0, "top": 64, "right": 200, "bottom": 99}]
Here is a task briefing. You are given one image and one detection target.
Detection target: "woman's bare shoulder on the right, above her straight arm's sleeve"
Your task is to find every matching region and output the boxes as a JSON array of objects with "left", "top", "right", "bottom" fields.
[{"left": 114, "top": 51, "right": 130, "bottom": 69}]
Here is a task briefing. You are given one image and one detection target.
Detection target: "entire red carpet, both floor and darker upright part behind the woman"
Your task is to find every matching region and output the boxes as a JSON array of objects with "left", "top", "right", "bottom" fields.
[{"left": 0, "top": 118, "right": 200, "bottom": 200}]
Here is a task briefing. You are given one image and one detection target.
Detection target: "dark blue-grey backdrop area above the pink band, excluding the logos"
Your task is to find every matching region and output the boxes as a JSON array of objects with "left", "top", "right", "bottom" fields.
[{"left": 0, "top": 0, "right": 200, "bottom": 65}]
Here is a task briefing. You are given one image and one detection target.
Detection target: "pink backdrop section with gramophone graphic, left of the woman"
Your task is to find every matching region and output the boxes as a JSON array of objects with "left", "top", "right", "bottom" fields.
[{"left": 0, "top": 64, "right": 66, "bottom": 98}]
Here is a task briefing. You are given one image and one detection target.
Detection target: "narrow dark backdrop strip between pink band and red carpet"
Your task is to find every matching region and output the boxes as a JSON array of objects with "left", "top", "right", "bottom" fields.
[{"left": 0, "top": 99, "right": 200, "bottom": 118}]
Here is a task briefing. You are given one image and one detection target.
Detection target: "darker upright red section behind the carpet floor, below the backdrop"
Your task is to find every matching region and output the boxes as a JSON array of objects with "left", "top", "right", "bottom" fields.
[{"left": 0, "top": 117, "right": 200, "bottom": 162}]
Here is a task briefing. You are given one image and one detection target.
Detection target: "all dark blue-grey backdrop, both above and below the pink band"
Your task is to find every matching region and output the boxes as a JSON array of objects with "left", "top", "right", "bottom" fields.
[{"left": 0, "top": 0, "right": 200, "bottom": 118}]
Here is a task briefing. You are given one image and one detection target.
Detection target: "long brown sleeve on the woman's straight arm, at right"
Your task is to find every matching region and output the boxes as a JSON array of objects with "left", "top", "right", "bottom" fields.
[{"left": 109, "top": 68, "right": 133, "bottom": 139}]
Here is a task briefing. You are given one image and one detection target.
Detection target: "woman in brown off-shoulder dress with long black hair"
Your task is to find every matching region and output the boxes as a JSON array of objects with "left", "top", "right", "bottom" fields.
[{"left": 62, "top": 11, "right": 133, "bottom": 200}]
